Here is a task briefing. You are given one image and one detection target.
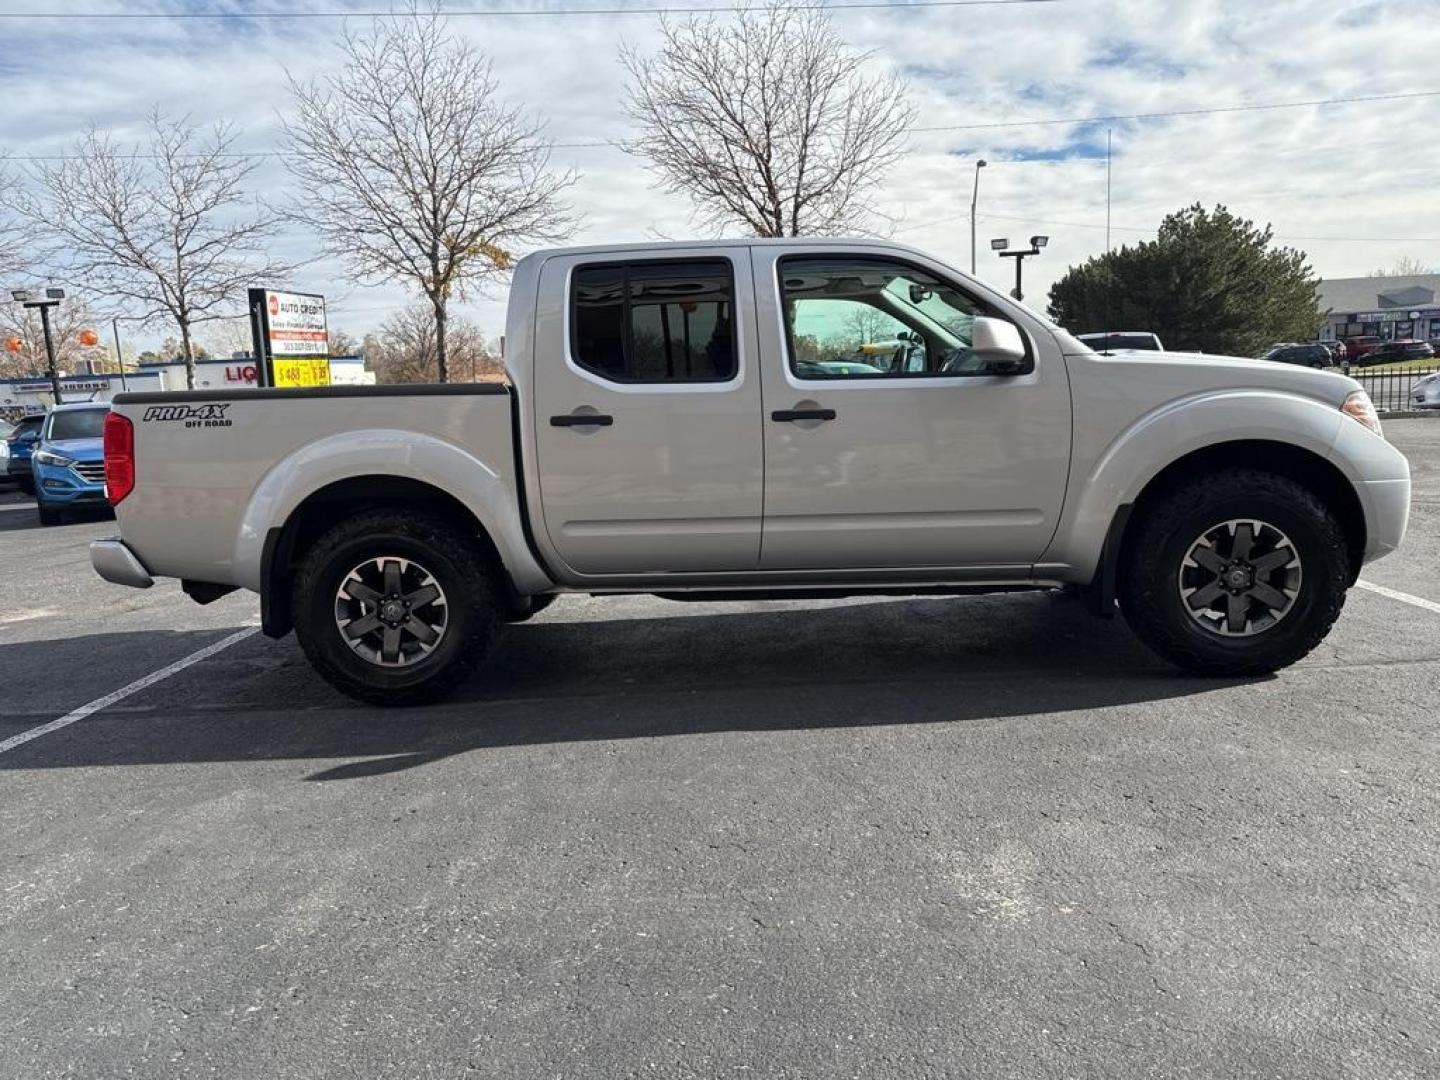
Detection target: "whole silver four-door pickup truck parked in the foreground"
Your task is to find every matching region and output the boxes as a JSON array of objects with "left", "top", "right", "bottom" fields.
[{"left": 92, "top": 239, "right": 1410, "bottom": 704}]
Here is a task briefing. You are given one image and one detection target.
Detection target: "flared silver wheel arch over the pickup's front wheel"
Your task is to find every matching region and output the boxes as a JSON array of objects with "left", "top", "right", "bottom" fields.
[{"left": 1041, "top": 389, "right": 1347, "bottom": 582}]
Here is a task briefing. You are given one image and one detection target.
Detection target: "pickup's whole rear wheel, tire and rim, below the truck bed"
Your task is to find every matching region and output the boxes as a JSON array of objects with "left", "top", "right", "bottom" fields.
[{"left": 292, "top": 510, "right": 501, "bottom": 706}]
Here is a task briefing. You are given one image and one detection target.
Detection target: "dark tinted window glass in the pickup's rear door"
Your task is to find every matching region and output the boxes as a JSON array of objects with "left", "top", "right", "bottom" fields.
[{"left": 570, "top": 259, "right": 739, "bottom": 383}]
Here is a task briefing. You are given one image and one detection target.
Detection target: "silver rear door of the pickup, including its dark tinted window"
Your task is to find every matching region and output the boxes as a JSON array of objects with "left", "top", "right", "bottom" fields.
[{"left": 531, "top": 246, "right": 765, "bottom": 576}]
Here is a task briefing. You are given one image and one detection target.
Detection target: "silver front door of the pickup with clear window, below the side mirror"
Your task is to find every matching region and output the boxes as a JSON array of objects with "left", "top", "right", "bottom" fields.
[{"left": 753, "top": 246, "right": 1070, "bottom": 569}]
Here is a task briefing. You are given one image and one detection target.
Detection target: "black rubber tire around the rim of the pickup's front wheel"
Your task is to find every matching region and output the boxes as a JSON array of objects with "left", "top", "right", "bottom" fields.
[{"left": 1117, "top": 468, "right": 1351, "bottom": 675}]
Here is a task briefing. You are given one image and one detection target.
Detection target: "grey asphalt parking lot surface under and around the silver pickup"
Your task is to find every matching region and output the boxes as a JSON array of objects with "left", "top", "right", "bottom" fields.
[{"left": 8, "top": 419, "right": 1440, "bottom": 1079}]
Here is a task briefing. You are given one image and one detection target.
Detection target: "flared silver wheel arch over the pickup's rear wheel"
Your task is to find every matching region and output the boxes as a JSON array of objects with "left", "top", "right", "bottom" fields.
[{"left": 233, "top": 428, "right": 550, "bottom": 593}]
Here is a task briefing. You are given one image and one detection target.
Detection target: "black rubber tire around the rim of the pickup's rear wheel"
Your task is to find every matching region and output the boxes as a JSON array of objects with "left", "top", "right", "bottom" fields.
[{"left": 291, "top": 510, "right": 501, "bottom": 706}]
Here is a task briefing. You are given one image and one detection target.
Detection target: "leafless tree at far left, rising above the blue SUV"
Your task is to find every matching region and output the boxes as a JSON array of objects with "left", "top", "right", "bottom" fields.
[{"left": 19, "top": 109, "right": 289, "bottom": 386}]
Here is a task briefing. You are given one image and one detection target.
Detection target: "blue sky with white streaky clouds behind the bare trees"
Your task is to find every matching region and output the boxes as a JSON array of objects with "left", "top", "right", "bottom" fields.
[{"left": 0, "top": 0, "right": 1440, "bottom": 355}]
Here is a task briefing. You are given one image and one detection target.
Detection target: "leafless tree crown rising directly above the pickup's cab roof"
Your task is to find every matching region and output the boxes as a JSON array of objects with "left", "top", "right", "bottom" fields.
[{"left": 621, "top": 6, "right": 912, "bottom": 236}]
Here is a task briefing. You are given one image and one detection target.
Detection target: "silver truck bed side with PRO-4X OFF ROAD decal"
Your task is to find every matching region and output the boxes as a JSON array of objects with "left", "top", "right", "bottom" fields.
[{"left": 114, "top": 383, "right": 517, "bottom": 589}]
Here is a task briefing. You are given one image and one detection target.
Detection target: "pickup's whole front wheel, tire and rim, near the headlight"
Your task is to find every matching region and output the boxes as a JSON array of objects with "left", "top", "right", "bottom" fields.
[{"left": 1119, "top": 468, "right": 1349, "bottom": 675}]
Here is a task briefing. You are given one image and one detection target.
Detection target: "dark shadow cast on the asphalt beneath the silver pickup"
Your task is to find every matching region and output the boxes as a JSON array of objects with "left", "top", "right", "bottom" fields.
[{"left": 0, "top": 595, "right": 1261, "bottom": 780}]
